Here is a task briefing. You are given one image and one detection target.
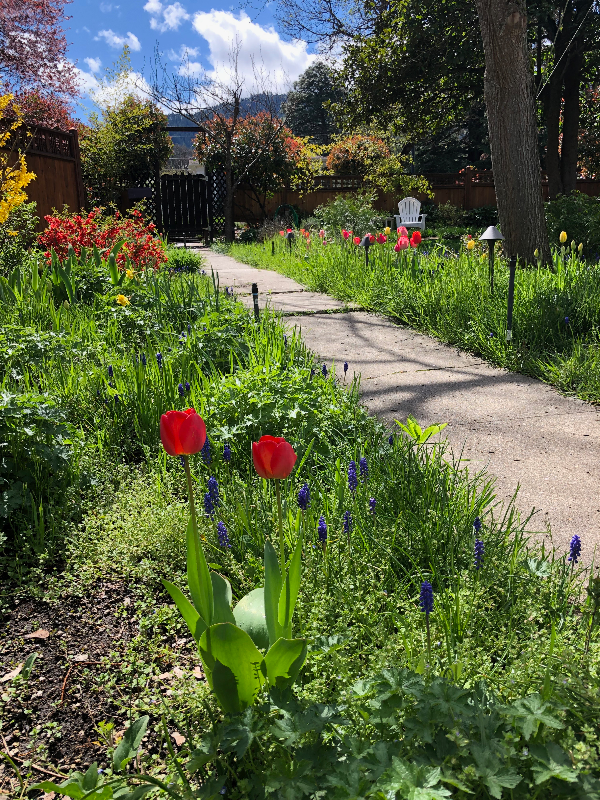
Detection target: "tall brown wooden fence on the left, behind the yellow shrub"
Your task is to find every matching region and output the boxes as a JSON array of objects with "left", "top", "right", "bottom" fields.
[{"left": 2, "top": 128, "right": 85, "bottom": 231}]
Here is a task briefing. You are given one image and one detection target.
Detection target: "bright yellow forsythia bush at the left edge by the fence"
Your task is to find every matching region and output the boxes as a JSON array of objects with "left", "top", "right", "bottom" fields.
[{"left": 0, "top": 94, "right": 35, "bottom": 225}]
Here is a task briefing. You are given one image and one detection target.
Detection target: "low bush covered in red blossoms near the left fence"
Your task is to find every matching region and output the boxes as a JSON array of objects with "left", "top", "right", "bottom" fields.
[{"left": 38, "top": 208, "right": 167, "bottom": 269}]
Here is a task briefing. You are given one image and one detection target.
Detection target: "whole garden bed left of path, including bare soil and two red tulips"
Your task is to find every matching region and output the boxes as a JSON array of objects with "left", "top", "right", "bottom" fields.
[{"left": 0, "top": 219, "right": 600, "bottom": 800}]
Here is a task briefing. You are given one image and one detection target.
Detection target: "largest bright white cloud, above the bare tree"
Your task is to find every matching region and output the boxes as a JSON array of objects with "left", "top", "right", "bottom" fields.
[{"left": 193, "top": 9, "right": 317, "bottom": 92}]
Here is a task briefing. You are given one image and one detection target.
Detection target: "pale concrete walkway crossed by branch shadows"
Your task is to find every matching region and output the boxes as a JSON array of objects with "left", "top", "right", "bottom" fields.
[{"left": 202, "top": 250, "right": 600, "bottom": 559}]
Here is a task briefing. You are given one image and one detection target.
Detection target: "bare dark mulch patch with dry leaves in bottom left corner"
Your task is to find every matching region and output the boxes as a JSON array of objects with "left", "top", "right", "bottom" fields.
[{"left": 0, "top": 582, "right": 144, "bottom": 798}]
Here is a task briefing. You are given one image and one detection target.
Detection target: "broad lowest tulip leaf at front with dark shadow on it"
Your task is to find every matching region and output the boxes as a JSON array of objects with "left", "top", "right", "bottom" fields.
[{"left": 198, "top": 622, "right": 264, "bottom": 713}]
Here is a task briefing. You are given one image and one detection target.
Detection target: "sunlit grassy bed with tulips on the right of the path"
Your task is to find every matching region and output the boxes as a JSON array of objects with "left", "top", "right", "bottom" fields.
[{"left": 230, "top": 220, "right": 600, "bottom": 402}]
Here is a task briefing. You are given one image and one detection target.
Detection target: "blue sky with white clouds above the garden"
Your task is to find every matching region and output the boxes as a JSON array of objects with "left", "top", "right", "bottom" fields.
[{"left": 67, "top": 0, "right": 315, "bottom": 120}]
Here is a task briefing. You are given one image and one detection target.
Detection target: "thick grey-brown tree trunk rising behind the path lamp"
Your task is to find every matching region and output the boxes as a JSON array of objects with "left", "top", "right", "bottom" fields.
[{"left": 477, "top": 0, "right": 550, "bottom": 262}]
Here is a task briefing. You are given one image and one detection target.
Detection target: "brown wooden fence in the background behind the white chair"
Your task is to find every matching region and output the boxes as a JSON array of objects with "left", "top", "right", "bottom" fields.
[{"left": 235, "top": 168, "right": 600, "bottom": 222}]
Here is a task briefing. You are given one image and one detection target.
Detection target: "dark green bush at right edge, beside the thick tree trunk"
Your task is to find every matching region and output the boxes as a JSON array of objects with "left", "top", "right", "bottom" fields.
[{"left": 546, "top": 192, "right": 600, "bottom": 261}]
